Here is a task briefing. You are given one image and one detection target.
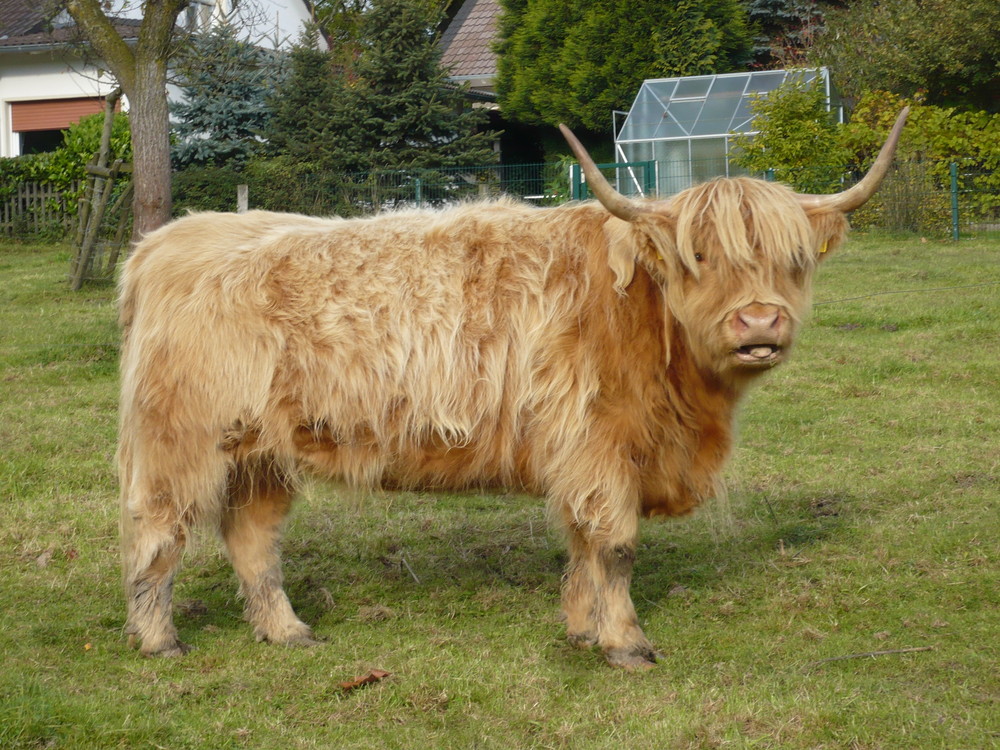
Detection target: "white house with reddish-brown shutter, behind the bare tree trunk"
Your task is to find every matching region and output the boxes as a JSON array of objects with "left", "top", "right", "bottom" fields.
[{"left": 0, "top": 0, "right": 312, "bottom": 157}]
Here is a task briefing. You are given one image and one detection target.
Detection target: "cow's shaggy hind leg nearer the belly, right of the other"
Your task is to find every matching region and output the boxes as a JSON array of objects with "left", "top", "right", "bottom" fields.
[{"left": 222, "top": 462, "right": 316, "bottom": 645}]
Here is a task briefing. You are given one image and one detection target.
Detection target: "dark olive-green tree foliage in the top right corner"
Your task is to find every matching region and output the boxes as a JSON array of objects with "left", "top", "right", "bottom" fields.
[{"left": 814, "top": 0, "right": 1000, "bottom": 112}]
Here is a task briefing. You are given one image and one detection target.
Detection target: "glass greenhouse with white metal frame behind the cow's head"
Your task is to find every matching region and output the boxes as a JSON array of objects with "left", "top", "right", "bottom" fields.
[{"left": 615, "top": 68, "right": 842, "bottom": 196}]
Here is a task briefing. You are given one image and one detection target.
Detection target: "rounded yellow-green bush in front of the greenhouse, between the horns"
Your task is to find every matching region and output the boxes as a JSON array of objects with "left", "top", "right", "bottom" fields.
[{"left": 733, "top": 76, "right": 850, "bottom": 193}]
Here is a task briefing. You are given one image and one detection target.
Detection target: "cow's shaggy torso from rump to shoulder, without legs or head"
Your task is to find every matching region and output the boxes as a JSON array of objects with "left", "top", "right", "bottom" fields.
[{"left": 121, "top": 203, "right": 600, "bottom": 490}]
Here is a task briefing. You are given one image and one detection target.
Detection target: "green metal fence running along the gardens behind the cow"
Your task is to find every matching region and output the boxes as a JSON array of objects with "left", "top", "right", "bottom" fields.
[{"left": 232, "top": 160, "right": 1000, "bottom": 239}]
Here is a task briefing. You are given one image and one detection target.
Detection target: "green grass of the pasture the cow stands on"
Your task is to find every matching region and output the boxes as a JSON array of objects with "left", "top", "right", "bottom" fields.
[{"left": 0, "top": 236, "right": 1000, "bottom": 749}]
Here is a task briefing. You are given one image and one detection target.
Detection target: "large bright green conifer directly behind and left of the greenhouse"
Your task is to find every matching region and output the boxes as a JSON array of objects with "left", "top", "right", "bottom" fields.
[{"left": 497, "top": 0, "right": 752, "bottom": 130}]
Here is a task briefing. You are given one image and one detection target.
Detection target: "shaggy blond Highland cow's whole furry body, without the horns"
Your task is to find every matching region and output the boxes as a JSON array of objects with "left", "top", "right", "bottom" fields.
[{"left": 119, "top": 179, "right": 845, "bottom": 667}]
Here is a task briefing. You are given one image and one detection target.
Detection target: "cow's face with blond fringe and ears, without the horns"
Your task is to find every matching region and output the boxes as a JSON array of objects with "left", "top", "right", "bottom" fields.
[{"left": 652, "top": 179, "right": 846, "bottom": 380}]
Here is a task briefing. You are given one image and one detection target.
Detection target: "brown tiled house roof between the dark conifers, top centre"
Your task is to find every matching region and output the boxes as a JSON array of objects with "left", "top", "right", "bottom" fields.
[{"left": 440, "top": 0, "right": 500, "bottom": 80}]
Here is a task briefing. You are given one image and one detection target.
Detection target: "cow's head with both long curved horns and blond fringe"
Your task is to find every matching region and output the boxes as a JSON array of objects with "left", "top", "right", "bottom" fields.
[{"left": 560, "top": 108, "right": 908, "bottom": 388}]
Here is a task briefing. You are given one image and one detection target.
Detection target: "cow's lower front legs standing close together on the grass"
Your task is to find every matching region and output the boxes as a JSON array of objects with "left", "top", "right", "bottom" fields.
[{"left": 562, "top": 524, "right": 656, "bottom": 669}]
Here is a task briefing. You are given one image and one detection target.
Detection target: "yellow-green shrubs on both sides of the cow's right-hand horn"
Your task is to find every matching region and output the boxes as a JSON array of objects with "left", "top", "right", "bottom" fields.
[{"left": 734, "top": 82, "right": 1000, "bottom": 232}]
